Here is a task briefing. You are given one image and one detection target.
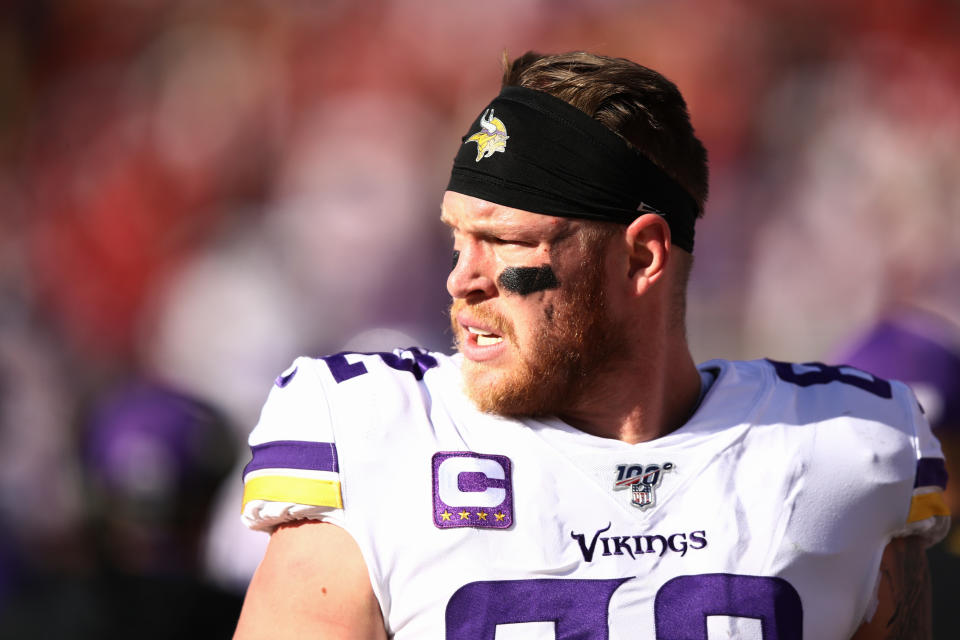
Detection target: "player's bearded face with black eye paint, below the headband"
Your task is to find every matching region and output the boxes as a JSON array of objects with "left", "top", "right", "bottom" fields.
[{"left": 443, "top": 191, "right": 624, "bottom": 416}]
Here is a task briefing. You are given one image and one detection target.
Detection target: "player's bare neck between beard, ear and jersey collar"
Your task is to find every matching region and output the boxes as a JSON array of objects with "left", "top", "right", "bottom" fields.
[{"left": 560, "top": 335, "right": 700, "bottom": 444}]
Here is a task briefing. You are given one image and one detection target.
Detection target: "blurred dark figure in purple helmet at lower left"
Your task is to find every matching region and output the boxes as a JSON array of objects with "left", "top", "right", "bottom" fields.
[{"left": 0, "top": 381, "right": 241, "bottom": 639}]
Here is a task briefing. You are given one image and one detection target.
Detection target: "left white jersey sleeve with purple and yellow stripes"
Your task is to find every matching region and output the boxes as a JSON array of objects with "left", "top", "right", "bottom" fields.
[{"left": 242, "top": 358, "right": 343, "bottom": 531}]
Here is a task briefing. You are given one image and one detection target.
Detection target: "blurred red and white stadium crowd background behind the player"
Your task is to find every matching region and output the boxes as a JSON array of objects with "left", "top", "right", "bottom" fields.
[{"left": 0, "top": 0, "right": 960, "bottom": 637}]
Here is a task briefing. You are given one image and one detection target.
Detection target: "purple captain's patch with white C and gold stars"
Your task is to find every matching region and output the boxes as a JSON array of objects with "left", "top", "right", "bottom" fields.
[{"left": 433, "top": 451, "right": 513, "bottom": 529}]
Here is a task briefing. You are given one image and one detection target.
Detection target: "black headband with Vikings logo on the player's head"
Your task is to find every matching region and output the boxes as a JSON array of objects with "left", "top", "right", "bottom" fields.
[{"left": 447, "top": 87, "right": 698, "bottom": 252}]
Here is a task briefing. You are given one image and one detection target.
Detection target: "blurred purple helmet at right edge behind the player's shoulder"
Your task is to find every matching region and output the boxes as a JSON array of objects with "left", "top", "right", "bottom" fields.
[{"left": 832, "top": 307, "right": 960, "bottom": 433}]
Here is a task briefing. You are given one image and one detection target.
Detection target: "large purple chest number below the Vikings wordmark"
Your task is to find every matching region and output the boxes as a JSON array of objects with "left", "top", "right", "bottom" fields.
[{"left": 446, "top": 573, "right": 803, "bottom": 640}]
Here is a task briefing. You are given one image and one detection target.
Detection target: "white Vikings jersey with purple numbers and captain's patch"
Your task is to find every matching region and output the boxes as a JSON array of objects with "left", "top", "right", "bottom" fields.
[{"left": 243, "top": 349, "right": 947, "bottom": 640}]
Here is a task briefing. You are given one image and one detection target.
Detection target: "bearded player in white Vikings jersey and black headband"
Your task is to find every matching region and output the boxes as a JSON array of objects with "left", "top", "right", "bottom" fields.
[{"left": 231, "top": 53, "right": 948, "bottom": 640}]
